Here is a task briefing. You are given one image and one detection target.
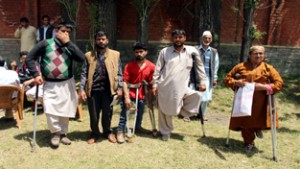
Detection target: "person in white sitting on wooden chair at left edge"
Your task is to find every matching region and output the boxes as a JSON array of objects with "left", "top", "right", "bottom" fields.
[{"left": 0, "top": 56, "right": 20, "bottom": 121}]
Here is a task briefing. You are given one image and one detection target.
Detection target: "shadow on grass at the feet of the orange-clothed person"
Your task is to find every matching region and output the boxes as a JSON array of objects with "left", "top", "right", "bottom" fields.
[{"left": 198, "top": 136, "right": 262, "bottom": 160}]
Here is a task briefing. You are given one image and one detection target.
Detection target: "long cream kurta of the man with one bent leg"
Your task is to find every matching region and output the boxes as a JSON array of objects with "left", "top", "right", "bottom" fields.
[{"left": 153, "top": 45, "right": 205, "bottom": 115}]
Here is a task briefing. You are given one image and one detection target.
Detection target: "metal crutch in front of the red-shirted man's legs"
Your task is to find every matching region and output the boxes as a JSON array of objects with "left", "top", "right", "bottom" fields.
[{"left": 126, "top": 83, "right": 141, "bottom": 143}]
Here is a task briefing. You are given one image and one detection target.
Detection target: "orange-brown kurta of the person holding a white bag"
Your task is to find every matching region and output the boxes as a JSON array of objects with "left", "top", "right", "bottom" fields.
[{"left": 223, "top": 62, "right": 283, "bottom": 130}]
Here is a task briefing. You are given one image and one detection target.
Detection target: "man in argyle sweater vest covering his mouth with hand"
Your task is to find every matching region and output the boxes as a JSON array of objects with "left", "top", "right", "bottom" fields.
[{"left": 26, "top": 22, "right": 84, "bottom": 148}]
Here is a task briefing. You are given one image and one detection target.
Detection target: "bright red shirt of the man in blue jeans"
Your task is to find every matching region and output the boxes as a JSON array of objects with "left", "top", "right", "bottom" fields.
[{"left": 123, "top": 59, "right": 155, "bottom": 100}]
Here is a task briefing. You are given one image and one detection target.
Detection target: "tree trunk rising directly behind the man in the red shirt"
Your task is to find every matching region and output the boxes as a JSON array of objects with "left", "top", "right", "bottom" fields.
[{"left": 132, "top": 0, "right": 160, "bottom": 44}]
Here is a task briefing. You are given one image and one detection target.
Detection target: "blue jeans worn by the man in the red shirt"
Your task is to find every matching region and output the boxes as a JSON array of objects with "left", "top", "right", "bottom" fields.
[{"left": 117, "top": 98, "right": 144, "bottom": 131}]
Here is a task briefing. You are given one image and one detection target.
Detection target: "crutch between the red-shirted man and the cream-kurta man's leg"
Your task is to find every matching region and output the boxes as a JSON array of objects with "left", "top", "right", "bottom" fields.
[{"left": 143, "top": 80, "right": 158, "bottom": 137}]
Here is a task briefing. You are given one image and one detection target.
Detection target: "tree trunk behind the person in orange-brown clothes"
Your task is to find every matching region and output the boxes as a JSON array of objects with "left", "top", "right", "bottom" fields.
[{"left": 240, "top": 0, "right": 258, "bottom": 62}]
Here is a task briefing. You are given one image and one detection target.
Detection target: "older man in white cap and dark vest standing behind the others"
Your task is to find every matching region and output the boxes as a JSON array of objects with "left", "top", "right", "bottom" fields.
[{"left": 193, "top": 31, "right": 219, "bottom": 121}]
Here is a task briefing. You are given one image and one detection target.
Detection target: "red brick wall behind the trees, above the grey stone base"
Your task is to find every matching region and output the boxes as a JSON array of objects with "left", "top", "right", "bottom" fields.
[{"left": 0, "top": 0, "right": 300, "bottom": 46}]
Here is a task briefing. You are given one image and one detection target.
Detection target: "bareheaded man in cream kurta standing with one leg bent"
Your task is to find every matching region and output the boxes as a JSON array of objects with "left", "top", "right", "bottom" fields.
[{"left": 152, "top": 29, "right": 206, "bottom": 141}]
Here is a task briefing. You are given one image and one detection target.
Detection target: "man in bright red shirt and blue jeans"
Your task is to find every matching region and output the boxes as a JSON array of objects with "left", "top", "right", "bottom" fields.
[{"left": 117, "top": 42, "right": 155, "bottom": 143}]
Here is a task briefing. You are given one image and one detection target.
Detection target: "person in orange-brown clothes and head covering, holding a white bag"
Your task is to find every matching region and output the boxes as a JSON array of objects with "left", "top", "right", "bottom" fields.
[{"left": 223, "top": 46, "right": 283, "bottom": 153}]
